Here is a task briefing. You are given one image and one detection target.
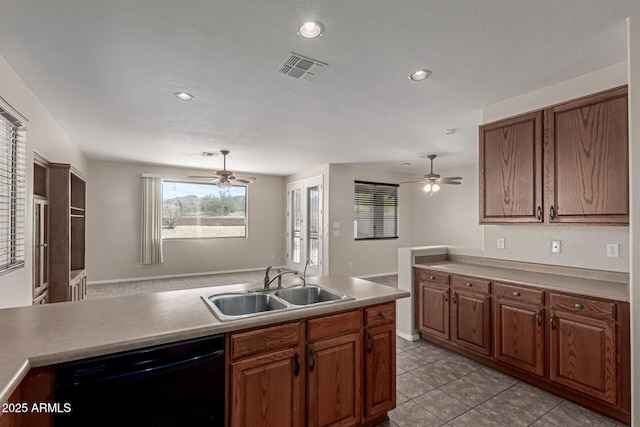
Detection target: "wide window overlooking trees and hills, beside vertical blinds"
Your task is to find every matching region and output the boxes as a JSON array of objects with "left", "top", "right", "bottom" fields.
[{"left": 162, "top": 181, "right": 247, "bottom": 239}]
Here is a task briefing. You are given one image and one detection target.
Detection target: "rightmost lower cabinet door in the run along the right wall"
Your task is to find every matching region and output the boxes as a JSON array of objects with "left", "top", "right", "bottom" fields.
[{"left": 550, "top": 311, "right": 618, "bottom": 404}]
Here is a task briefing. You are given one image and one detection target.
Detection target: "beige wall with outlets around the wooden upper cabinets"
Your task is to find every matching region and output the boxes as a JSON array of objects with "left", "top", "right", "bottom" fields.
[{"left": 416, "top": 63, "right": 630, "bottom": 272}]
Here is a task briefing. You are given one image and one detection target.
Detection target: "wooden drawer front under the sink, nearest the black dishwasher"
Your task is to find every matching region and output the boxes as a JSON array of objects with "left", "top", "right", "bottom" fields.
[{"left": 229, "top": 322, "right": 300, "bottom": 359}]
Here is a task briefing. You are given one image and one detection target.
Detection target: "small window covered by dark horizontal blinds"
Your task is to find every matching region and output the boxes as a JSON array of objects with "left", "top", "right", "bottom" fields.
[{"left": 353, "top": 181, "right": 398, "bottom": 240}]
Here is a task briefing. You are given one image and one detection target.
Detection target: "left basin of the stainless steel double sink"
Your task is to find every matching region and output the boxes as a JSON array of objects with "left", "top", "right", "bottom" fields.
[{"left": 202, "top": 292, "right": 287, "bottom": 320}]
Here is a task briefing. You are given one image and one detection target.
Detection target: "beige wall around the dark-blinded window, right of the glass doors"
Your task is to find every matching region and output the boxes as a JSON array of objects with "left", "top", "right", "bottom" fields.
[{"left": 326, "top": 164, "right": 415, "bottom": 276}]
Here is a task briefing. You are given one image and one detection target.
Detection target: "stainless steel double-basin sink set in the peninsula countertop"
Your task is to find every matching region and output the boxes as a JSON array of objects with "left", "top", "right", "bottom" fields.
[{"left": 202, "top": 285, "right": 354, "bottom": 322}]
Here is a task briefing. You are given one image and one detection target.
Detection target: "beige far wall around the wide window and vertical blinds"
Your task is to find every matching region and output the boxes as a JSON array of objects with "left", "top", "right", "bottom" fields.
[{"left": 87, "top": 160, "right": 285, "bottom": 282}]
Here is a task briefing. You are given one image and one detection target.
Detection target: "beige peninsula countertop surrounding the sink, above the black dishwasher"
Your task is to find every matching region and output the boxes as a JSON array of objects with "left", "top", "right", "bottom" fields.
[{"left": 0, "top": 275, "right": 409, "bottom": 403}]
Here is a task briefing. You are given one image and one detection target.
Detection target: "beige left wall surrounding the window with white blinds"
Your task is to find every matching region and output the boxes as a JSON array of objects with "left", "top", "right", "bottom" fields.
[{"left": 0, "top": 57, "right": 87, "bottom": 308}]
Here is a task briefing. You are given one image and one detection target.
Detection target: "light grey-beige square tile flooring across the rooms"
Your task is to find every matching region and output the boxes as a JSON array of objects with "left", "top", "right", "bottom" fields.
[{"left": 87, "top": 271, "right": 624, "bottom": 427}]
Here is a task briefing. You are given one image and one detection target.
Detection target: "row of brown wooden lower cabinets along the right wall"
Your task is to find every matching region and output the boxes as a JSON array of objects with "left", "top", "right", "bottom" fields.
[{"left": 414, "top": 268, "right": 631, "bottom": 424}]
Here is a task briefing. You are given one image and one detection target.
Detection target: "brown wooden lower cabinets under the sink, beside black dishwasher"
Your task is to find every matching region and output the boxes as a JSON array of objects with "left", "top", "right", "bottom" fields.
[{"left": 227, "top": 302, "right": 396, "bottom": 427}]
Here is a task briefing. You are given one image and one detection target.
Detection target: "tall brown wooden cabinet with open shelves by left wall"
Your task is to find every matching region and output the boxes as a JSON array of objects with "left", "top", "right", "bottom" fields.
[{"left": 49, "top": 163, "right": 87, "bottom": 302}]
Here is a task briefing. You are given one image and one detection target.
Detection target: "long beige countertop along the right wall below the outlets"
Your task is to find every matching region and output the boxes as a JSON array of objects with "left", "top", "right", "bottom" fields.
[{"left": 414, "top": 261, "right": 629, "bottom": 302}]
